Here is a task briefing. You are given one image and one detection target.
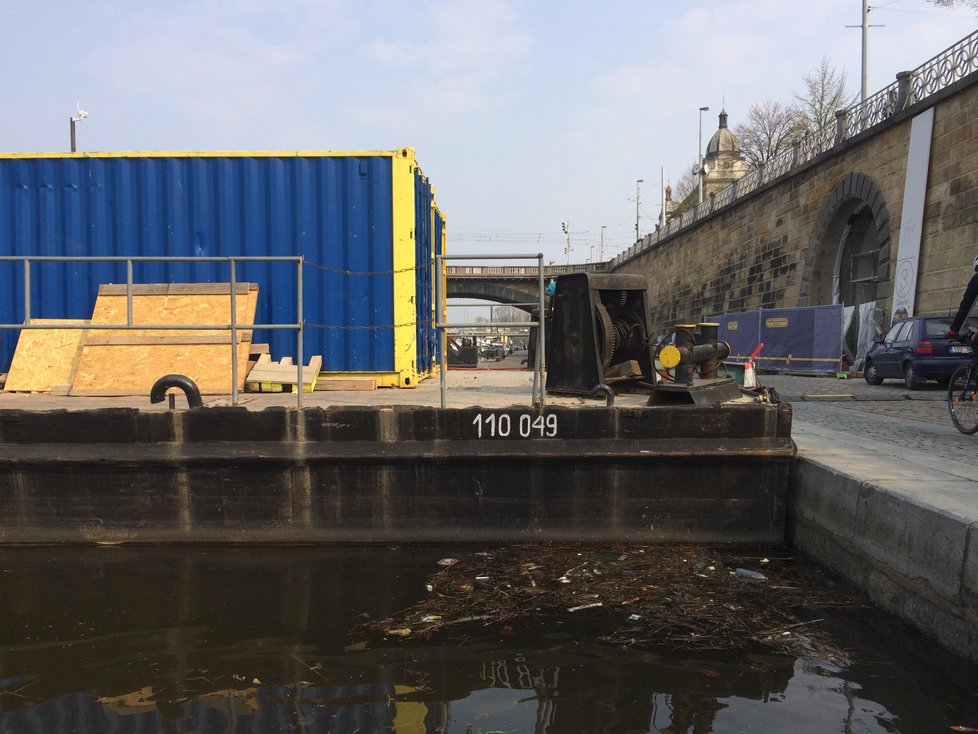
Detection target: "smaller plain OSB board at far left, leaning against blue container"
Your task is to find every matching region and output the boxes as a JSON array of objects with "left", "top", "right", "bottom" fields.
[{"left": 3, "top": 319, "right": 89, "bottom": 392}]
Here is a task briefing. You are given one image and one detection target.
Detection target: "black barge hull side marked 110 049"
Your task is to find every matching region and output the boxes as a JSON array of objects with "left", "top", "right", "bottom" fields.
[{"left": 0, "top": 403, "right": 796, "bottom": 545}]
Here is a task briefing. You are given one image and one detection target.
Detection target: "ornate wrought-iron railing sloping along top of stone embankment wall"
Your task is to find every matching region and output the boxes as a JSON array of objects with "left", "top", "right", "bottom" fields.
[{"left": 608, "top": 31, "right": 978, "bottom": 269}]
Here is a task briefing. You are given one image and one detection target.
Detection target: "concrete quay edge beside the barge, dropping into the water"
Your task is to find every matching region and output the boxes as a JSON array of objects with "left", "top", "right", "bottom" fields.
[{"left": 787, "top": 422, "right": 978, "bottom": 662}]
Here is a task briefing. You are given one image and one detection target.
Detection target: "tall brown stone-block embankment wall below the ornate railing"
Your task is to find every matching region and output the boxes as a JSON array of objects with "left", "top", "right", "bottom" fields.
[{"left": 616, "top": 74, "right": 978, "bottom": 332}]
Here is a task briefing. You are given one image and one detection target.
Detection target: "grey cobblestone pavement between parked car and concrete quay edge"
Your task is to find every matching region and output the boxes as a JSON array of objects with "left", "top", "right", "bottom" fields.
[{"left": 758, "top": 375, "right": 978, "bottom": 465}]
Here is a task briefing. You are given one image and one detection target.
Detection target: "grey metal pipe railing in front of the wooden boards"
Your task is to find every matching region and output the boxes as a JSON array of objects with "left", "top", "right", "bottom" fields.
[{"left": 0, "top": 255, "right": 305, "bottom": 408}]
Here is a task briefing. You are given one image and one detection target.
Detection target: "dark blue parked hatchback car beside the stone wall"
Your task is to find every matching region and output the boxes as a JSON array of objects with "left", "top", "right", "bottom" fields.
[{"left": 863, "top": 316, "right": 978, "bottom": 390}]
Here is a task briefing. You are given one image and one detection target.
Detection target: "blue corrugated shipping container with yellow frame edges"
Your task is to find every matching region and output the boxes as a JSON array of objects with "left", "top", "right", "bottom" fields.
[{"left": 0, "top": 148, "right": 444, "bottom": 386}]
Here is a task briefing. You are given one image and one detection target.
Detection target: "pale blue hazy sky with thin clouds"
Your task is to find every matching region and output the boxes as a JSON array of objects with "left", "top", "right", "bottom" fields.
[{"left": 0, "top": 0, "right": 978, "bottom": 272}]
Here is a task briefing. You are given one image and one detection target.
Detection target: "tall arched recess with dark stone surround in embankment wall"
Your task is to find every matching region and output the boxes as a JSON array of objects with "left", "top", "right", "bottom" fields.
[{"left": 799, "top": 171, "right": 891, "bottom": 368}]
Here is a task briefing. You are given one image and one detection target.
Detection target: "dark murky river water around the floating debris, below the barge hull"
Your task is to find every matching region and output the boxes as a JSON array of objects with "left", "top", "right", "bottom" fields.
[{"left": 0, "top": 546, "right": 978, "bottom": 734}]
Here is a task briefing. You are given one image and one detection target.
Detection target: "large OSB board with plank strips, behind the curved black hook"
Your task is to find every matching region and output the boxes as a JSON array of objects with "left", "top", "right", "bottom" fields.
[{"left": 71, "top": 283, "right": 258, "bottom": 395}]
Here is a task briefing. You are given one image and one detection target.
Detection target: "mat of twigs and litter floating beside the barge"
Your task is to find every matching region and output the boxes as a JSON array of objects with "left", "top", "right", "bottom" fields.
[{"left": 353, "top": 543, "right": 865, "bottom": 664}]
